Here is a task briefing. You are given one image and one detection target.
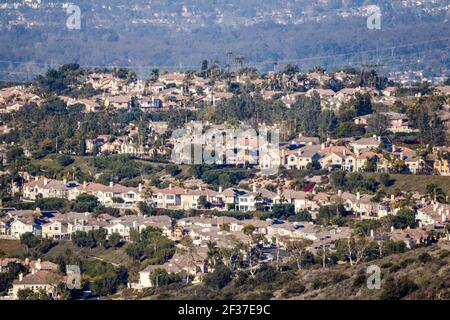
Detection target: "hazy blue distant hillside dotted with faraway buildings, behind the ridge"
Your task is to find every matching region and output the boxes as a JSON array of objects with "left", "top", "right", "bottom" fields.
[{"left": 0, "top": 0, "right": 450, "bottom": 80}]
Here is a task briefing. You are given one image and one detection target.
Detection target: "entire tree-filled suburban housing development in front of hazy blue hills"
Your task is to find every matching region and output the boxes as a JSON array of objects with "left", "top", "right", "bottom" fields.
[{"left": 0, "top": 60, "right": 450, "bottom": 300}]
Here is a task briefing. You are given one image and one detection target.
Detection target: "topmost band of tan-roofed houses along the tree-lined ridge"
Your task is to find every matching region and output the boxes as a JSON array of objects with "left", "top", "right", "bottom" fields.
[{"left": 4, "top": 71, "right": 450, "bottom": 115}]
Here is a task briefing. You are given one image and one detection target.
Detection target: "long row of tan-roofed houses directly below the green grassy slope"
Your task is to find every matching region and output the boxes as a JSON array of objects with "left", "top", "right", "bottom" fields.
[{"left": 11, "top": 169, "right": 450, "bottom": 231}]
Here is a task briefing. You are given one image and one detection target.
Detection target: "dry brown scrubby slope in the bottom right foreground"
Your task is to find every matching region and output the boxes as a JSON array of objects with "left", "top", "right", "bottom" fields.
[{"left": 137, "top": 245, "right": 450, "bottom": 300}]
